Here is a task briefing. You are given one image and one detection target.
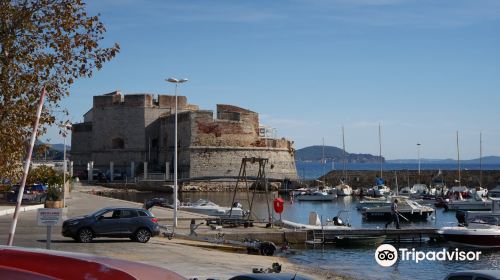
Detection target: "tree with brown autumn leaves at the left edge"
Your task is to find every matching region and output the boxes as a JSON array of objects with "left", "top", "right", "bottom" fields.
[{"left": 0, "top": 0, "right": 120, "bottom": 179}]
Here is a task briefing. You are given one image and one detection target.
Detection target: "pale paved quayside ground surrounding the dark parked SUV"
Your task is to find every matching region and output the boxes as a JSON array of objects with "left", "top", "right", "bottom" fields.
[{"left": 0, "top": 187, "right": 344, "bottom": 279}]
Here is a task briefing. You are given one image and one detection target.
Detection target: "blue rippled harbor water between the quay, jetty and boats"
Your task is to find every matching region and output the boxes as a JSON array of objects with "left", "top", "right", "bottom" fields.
[{"left": 103, "top": 192, "right": 500, "bottom": 279}]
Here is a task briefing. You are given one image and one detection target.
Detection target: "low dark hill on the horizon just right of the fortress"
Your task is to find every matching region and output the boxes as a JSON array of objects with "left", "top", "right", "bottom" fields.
[{"left": 295, "top": 146, "right": 385, "bottom": 163}]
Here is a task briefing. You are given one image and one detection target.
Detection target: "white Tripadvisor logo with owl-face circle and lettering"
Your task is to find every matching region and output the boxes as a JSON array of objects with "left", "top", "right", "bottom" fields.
[{"left": 375, "top": 244, "right": 481, "bottom": 267}]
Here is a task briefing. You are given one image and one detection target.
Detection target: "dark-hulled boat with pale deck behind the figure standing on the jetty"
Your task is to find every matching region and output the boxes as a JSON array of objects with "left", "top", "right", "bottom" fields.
[{"left": 361, "top": 196, "right": 434, "bottom": 221}]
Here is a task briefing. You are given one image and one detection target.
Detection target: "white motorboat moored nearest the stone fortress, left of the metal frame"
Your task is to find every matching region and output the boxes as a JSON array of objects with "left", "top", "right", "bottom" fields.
[{"left": 177, "top": 199, "right": 246, "bottom": 218}]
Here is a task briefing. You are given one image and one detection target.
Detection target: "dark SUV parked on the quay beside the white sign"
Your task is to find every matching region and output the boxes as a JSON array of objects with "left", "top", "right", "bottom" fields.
[{"left": 62, "top": 207, "right": 160, "bottom": 243}]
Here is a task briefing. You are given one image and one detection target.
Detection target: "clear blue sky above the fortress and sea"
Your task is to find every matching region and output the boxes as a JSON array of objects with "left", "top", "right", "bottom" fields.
[{"left": 44, "top": 0, "right": 500, "bottom": 159}]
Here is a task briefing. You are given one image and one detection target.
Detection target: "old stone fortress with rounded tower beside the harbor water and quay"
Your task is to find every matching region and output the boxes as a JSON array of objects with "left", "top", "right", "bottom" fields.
[{"left": 71, "top": 91, "right": 297, "bottom": 181}]
